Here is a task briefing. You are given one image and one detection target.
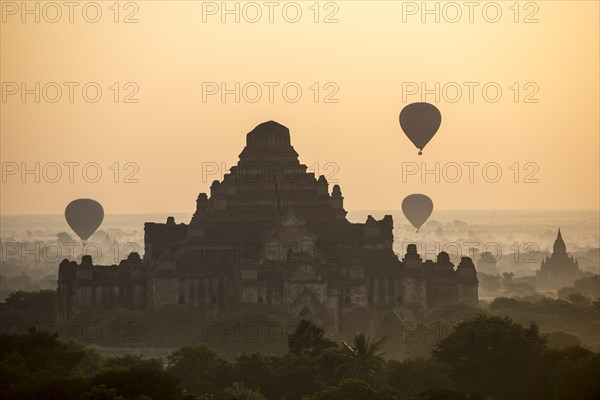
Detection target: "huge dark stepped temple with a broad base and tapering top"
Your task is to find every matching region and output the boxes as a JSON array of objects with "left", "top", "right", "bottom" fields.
[{"left": 58, "top": 121, "right": 478, "bottom": 331}]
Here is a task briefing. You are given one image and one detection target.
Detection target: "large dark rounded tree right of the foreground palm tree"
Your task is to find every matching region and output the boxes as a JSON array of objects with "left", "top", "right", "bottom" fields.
[{"left": 433, "top": 314, "right": 546, "bottom": 399}]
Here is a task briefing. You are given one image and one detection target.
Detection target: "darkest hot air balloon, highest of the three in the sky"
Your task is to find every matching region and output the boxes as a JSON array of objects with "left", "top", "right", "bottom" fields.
[{"left": 400, "top": 103, "right": 442, "bottom": 155}]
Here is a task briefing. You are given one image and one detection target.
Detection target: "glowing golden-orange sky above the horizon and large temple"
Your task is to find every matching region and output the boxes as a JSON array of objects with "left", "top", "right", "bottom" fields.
[{"left": 0, "top": 1, "right": 600, "bottom": 215}]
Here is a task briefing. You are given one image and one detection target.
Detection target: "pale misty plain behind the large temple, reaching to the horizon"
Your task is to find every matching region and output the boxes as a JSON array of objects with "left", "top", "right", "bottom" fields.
[{"left": 0, "top": 211, "right": 600, "bottom": 299}]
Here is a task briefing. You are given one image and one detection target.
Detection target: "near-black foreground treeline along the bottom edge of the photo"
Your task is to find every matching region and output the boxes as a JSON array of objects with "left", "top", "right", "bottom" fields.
[{"left": 0, "top": 314, "right": 600, "bottom": 400}]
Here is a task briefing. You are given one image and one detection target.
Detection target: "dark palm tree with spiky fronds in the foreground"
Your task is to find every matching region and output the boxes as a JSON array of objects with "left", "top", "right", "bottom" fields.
[{"left": 338, "top": 333, "right": 385, "bottom": 381}]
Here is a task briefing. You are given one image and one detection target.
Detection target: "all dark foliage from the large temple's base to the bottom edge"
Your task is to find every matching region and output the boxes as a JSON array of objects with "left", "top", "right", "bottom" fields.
[{"left": 0, "top": 290, "right": 600, "bottom": 400}]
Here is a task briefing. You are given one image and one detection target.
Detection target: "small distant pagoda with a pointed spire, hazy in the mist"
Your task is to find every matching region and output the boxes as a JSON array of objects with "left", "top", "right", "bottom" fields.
[{"left": 536, "top": 228, "right": 582, "bottom": 289}]
